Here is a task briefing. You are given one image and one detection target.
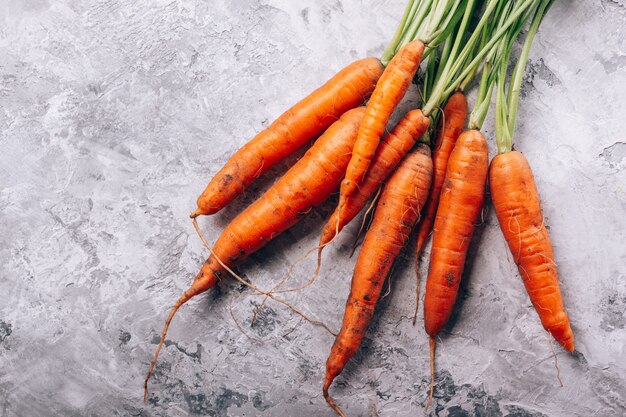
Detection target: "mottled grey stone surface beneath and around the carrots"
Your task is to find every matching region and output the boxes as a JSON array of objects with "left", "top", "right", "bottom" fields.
[{"left": 0, "top": 0, "right": 626, "bottom": 417}]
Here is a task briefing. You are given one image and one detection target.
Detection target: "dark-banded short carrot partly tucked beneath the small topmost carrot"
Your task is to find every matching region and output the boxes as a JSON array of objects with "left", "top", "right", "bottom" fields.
[{"left": 319, "top": 110, "right": 430, "bottom": 251}]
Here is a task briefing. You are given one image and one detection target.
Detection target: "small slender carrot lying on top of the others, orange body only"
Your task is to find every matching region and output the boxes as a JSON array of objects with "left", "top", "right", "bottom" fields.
[{"left": 339, "top": 41, "right": 424, "bottom": 207}]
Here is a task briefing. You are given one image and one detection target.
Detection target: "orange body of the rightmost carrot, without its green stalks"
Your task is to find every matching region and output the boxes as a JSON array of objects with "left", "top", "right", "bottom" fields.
[{"left": 489, "top": 151, "right": 574, "bottom": 352}]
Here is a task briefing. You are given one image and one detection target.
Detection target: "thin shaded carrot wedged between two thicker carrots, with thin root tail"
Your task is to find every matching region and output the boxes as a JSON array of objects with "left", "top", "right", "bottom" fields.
[{"left": 413, "top": 92, "right": 467, "bottom": 325}]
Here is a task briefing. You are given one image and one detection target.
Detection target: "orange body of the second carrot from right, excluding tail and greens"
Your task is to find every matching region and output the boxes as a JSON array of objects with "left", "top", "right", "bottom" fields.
[{"left": 424, "top": 130, "right": 489, "bottom": 338}]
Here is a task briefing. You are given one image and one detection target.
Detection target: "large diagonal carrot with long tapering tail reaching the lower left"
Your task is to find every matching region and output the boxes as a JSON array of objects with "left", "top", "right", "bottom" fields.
[{"left": 144, "top": 107, "right": 365, "bottom": 394}]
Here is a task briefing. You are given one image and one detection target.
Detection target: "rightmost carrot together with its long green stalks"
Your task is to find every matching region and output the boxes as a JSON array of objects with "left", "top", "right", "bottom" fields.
[{"left": 489, "top": 0, "right": 574, "bottom": 352}]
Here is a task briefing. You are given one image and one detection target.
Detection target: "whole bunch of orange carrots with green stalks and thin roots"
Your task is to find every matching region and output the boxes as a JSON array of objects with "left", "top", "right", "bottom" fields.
[{"left": 144, "top": 0, "right": 574, "bottom": 416}]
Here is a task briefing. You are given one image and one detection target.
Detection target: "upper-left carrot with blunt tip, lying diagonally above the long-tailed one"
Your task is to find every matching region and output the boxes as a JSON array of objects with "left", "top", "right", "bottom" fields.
[{"left": 191, "top": 58, "right": 383, "bottom": 218}]
